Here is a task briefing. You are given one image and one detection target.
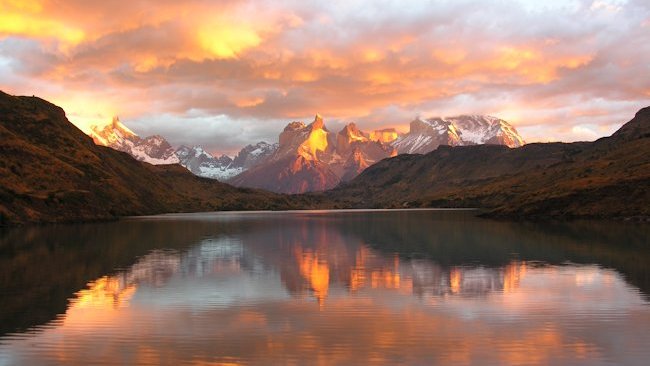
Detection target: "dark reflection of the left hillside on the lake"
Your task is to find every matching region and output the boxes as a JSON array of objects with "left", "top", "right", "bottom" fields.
[{"left": 0, "top": 220, "right": 256, "bottom": 334}]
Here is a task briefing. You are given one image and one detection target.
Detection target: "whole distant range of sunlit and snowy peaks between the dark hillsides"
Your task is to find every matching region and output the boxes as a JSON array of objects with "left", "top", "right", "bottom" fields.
[{"left": 90, "top": 115, "right": 524, "bottom": 193}]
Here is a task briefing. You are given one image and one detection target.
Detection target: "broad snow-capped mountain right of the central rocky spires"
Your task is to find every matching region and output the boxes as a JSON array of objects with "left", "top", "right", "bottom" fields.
[{"left": 391, "top": 115, "right": 524, "bottom": 154}]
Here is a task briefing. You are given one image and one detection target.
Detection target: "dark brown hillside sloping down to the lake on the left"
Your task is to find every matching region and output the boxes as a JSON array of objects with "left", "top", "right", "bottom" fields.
[{"left": 0, "top": 92, "right": 308, "bottom": 225}]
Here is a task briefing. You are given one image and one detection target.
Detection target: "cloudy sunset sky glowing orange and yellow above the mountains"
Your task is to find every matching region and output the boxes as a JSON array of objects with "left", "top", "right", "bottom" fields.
[{"left": 0, "top": 0, "right": 650, "bottom": 154}]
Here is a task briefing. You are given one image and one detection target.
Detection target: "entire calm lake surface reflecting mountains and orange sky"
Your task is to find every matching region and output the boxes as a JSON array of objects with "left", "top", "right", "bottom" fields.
[{"left": 0, "top": 211, "right": 650, "bottom": 365}]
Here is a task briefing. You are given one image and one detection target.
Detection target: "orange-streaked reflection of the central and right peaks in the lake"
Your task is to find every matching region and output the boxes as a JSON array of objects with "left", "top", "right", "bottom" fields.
[{"left": 281, "top": 243, "right": 526, "bottom": 306}]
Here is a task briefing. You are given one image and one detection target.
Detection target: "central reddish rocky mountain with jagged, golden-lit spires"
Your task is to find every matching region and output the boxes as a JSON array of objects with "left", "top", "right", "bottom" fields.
[{"left": 229, "top": 115, "right": 397, "bottom": 193}]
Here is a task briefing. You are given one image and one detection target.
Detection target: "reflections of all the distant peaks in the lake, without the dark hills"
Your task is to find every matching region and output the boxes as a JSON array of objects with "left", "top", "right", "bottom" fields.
[{"left": 71, "top": 238, "right": 526, "bottom": 310}]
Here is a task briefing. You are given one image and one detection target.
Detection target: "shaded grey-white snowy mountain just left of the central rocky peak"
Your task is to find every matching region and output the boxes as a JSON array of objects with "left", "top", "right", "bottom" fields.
[{"left": 176, "top": 145, "right": 243, "bottom": 180}]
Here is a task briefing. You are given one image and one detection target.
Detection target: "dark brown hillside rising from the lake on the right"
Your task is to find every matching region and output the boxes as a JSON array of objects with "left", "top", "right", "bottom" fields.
[{"left": 327, "top": 107, "right": 650, "bottom": 218}]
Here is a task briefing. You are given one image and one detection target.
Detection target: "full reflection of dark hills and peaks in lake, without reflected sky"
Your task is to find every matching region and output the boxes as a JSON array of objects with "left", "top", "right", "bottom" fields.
[{"left": 0, "top": 211, "right": 650, "bottom": 334}]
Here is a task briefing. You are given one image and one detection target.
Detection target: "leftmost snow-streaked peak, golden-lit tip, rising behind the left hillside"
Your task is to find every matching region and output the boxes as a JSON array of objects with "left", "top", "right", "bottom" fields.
[{"left": 90, "top": 117, "right": 179, "bottom": 164}]
